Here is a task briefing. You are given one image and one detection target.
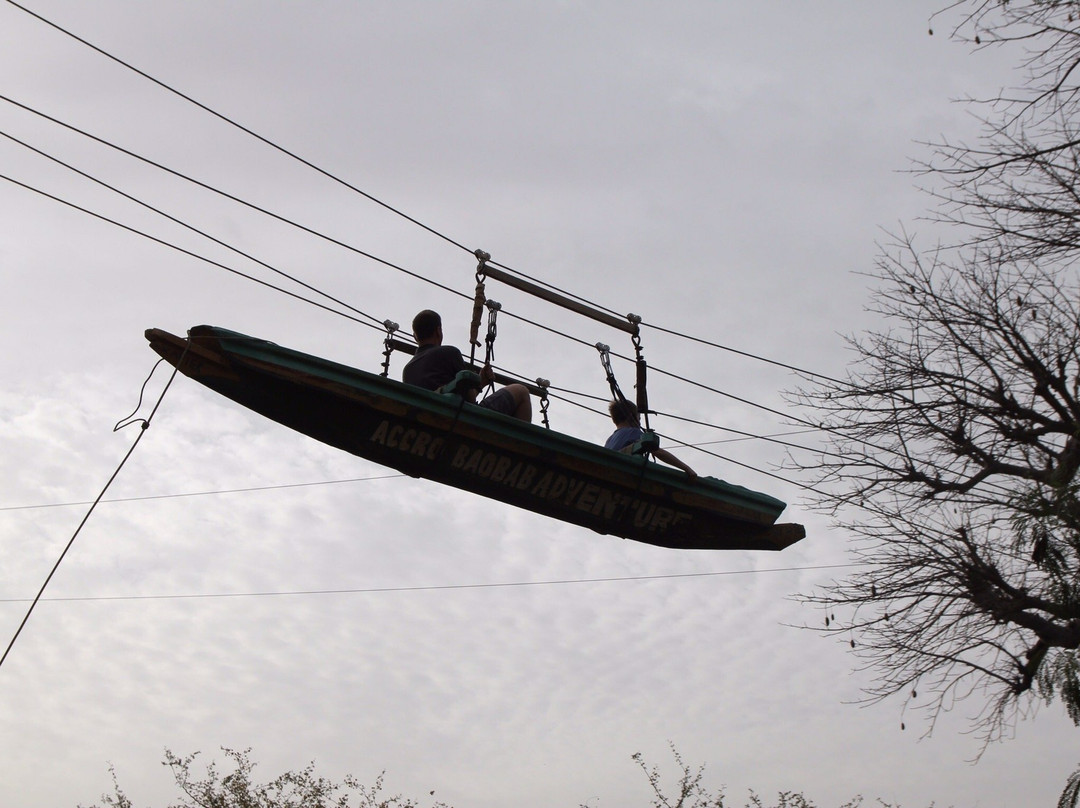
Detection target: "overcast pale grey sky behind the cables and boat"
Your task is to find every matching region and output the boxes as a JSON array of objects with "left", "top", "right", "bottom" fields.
[{"left": 0, "top": 0, "right": 1077, "bottom": 808}]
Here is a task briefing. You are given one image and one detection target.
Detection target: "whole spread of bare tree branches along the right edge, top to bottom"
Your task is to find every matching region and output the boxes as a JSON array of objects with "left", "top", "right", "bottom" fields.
[{"left": 793, "top": 0, "right": 1080, "bottom": 756}]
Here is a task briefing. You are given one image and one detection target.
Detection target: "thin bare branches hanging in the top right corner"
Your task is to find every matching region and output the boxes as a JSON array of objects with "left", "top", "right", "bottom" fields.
[{"left": 922, "top": 0, "right": 1080, "bottom": 262}]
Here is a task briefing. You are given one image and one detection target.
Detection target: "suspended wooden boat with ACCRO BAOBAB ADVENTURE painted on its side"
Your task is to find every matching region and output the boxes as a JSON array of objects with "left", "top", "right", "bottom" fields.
[{"left": 146, "top": 325, "right": 806, "bottom": 550}]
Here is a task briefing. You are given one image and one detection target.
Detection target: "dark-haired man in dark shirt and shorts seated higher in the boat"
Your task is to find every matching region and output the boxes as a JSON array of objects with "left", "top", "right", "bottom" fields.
[{"left": 402, "top": 309, "right": 532, "bottom": 421}]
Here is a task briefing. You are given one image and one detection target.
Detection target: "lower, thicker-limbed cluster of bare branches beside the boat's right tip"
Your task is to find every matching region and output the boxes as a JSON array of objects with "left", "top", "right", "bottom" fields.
[{"left": 786, "top": 244, "right": 1080, "bottom": 740}]
